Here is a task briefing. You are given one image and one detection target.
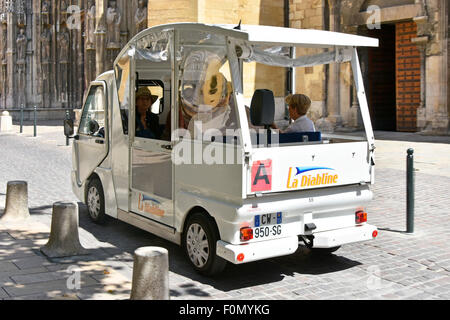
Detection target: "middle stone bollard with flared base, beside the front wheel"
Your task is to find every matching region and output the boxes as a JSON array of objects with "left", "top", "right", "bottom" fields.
[{"left": 41, "top": 202, "right": 88, "bottom": 258}]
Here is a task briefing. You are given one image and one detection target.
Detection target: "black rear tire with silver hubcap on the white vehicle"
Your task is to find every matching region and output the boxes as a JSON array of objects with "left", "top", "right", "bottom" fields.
[{"left": 182, "top": 212, "right": 227, "bottom": 276}]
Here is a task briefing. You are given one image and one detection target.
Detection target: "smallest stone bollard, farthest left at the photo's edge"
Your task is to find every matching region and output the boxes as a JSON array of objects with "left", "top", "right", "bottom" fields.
[{"left": 0, "top": 181, "right": 30, "bottom": 221}]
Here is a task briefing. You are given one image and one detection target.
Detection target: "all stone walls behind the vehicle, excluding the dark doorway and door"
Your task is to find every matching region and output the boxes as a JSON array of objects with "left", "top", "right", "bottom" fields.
[{"left": 0, "top": 0, "right": 444, "bottom": 133}]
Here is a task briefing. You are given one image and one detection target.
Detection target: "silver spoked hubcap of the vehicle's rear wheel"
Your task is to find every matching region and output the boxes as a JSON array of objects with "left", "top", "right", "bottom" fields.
[{"left": 186, "top": 223, "right": 209, "bottom": 268}]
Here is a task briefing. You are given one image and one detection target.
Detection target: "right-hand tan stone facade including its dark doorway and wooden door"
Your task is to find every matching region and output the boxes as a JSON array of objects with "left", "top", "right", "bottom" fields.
[{"left": 289, "top": 0, "right": 450, "bottom": 134}]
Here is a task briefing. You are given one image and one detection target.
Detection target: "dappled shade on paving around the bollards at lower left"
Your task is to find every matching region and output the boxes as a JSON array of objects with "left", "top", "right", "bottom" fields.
[{"left": 0, "top": 225, "right": 131, "bottom": 300}]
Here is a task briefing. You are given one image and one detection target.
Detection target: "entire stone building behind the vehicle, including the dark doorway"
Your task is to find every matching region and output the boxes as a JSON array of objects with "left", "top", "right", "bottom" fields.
[{"left": 0, "top": 0, "right": 450, "bottom": 134}]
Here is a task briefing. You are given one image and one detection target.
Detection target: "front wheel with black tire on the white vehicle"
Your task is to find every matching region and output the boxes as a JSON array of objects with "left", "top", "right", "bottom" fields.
[{"left": 86, "top": 178, "right": 107, "bottom": 224}]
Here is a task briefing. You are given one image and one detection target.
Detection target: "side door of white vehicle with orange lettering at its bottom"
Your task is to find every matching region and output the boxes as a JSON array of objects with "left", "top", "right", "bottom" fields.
[{"left": 130, "top": 74, "right": 174, "bottom": 226}]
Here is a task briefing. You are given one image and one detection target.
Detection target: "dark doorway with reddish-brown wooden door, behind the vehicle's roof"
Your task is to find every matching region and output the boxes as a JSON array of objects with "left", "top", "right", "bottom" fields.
[{"left": 360, "top": 0, "right": 422, "bottom": 132}]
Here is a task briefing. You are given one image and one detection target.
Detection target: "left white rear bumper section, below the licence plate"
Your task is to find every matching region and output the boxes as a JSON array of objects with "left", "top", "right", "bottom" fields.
[{"left": 216, "top": 236, "right": 298, "bottom": 264}]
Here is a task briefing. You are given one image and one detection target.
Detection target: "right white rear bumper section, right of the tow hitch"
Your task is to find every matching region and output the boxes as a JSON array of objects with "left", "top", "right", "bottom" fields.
[{"left": 313, "top": 224, "right": 378, "bottom": 248}]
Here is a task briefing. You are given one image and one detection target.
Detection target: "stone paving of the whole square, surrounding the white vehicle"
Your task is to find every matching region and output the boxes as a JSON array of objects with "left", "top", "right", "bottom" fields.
[{"left": 0, "top": 126, "right": 450, "bottom": 300}]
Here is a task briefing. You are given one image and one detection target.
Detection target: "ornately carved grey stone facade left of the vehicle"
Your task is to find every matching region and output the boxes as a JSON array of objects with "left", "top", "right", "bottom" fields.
[{"left": 0, "top": 0, "right": 148, "bottom": 119}]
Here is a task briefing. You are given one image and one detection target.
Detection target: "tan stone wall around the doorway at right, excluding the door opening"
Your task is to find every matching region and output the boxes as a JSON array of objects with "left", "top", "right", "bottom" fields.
[{"left": 289, "top": 0, "right": 450, "bottom": 133}]
